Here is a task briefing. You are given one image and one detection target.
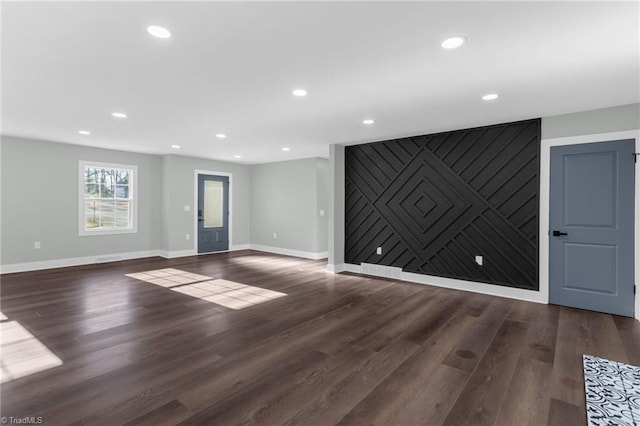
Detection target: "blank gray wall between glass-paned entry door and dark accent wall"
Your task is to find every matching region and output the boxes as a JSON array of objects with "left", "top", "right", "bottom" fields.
[{"left": 251, "top": 158, "right": 328, "bottom": 253}]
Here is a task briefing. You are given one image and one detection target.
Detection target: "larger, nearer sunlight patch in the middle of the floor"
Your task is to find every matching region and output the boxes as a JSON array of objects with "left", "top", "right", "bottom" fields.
[{"left": 171, "top": 279, "right": 286, "bottom": 309}]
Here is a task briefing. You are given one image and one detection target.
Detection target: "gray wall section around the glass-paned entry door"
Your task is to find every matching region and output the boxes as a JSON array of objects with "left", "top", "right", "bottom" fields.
[{"left": 162, "top": 155, "right": 251, "bottom": 252}]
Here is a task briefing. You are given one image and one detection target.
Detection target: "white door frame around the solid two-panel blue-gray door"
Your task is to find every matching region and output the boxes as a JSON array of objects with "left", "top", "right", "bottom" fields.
[{"left": 539, "top": 129, "right": 640, "bottom": 320}]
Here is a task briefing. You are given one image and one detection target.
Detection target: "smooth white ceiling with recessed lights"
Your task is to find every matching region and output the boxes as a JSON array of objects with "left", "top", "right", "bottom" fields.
[{"left": 1, "top": 1, "right": 640, "bottom": 163}]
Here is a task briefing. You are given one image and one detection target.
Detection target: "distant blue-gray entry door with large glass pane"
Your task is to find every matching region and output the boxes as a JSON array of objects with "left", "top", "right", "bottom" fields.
[{"left": 198, "top": 175, "right": 229, "bottom": 253}]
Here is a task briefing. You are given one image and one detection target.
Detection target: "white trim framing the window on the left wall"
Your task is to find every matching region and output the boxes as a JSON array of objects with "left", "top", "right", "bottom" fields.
[{"left": 78, "top": 160, "right": 138, "bottom": 237}]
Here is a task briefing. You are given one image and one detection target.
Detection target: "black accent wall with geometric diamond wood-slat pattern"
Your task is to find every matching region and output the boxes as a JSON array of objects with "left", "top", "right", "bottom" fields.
[{"left": 345, "top": 119, "right": 540, "bottom": 290}]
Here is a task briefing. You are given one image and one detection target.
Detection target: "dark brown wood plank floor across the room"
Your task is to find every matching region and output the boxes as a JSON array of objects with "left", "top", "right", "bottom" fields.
[{"left": 0, "top": 251, "right": 640, "bottom": 426}]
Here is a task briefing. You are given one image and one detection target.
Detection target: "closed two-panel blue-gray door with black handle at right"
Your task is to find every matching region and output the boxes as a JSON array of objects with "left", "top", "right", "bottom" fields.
[{"left": 549, "top": 140, "right": 635, "bottom": 316}]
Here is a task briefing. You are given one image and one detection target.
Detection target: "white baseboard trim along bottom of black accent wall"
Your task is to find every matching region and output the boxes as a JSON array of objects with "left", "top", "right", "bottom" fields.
[{"left": 327, "top": 263, "right": 548, "bottom": 304}]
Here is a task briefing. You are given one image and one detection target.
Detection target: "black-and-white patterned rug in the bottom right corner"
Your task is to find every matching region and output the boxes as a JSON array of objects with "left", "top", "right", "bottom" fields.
[{"left": 582, "top": 355, "right": 640, "bottom": 426}]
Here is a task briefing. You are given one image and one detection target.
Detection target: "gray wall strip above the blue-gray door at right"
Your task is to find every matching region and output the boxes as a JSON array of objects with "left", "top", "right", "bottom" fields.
[{"left": 542, "top": 104, "right": 640, "bottom": 139}]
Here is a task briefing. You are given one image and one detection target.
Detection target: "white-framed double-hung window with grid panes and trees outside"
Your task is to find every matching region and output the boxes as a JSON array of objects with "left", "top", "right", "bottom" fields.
[{"left": 80, "top": 161, "right": 138, "bottom": 235}]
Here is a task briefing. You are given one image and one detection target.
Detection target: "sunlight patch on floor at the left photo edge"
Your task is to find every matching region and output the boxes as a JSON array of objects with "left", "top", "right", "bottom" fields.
[{"left": 0, "top": 315, "right": 62, "bottom": 383}]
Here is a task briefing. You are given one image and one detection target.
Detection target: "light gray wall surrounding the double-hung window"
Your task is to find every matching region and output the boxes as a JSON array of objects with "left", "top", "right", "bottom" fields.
[{"left": 0, "top": 136, "right": 162, "bottom": 264}]
